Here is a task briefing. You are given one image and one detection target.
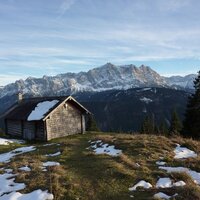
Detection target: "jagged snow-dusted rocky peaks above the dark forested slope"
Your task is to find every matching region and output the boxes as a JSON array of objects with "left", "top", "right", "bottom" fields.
[{"left": 0, "top": 63, "right": 195, "bottom": 98}]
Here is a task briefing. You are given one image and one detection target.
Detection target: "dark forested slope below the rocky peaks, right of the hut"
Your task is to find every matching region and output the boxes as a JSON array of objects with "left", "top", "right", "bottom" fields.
[{"left": 75, "top": 88, "right": 190, "bottom": 132}]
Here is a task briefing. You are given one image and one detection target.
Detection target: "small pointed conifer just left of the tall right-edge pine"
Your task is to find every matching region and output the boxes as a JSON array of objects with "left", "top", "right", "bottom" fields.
[{"left": 169, "top": 110, "right": 182, "bottom": 135}]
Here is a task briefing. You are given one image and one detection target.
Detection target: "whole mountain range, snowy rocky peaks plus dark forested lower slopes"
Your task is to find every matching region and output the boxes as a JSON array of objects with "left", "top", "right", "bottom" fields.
[{"left": 0, "top": 63, "right": 196, "bottom": 132}]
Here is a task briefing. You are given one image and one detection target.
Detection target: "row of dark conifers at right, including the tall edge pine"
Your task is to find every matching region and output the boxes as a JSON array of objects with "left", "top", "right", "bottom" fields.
[{"left": 141, "top": 71, "right": 200, "bottom": 139}]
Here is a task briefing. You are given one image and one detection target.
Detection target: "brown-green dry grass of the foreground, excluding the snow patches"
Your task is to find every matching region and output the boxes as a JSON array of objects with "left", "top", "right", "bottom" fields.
[{"left": 1, "top": 133, "right": 200, "bottom": 200}]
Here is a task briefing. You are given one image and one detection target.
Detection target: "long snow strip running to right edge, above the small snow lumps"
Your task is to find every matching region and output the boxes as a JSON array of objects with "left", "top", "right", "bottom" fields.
[{"left": 159, "top": 166, "right": 200, "bottom": 185}]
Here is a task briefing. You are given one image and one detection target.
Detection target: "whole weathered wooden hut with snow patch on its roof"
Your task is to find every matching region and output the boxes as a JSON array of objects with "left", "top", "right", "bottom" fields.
[{"left": 5, "top": 96, "right": 90, "bottom": 141}]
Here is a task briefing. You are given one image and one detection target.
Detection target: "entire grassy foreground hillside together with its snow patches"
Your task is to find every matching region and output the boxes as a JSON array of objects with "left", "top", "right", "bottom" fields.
[{"left": 0, "top": 133, "right": 200, "bottom": 200}]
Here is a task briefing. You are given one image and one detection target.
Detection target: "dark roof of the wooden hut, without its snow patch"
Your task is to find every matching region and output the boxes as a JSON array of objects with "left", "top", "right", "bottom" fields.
[{"left": 5, "top": 96, "right": 90, "bottom": 121}]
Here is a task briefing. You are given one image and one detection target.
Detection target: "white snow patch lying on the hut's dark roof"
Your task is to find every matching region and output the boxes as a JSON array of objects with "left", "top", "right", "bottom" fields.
[{"left": 27, "top": 100, "right": 59, "bottom": 121}]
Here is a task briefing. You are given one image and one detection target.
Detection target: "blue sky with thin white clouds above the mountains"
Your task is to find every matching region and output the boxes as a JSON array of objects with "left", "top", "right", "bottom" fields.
[{"left": 0, "top": 0, "right": 200, "bottom": 85}]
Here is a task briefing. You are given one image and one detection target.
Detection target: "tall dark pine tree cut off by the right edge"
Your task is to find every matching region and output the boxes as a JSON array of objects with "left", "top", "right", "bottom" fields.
[{"left": 182, "top": 71, "right": 200, "bottom": 138}]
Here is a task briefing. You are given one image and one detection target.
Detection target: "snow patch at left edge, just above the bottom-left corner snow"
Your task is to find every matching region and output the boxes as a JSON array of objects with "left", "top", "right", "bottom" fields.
[{"left": 0, "top": 173, "right": 26, "bottom": 196}]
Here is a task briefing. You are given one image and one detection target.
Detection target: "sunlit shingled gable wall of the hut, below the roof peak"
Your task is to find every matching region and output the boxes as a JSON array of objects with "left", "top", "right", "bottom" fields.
[{"left": 46, "top": 102, "right": 82, "bottom": 140}]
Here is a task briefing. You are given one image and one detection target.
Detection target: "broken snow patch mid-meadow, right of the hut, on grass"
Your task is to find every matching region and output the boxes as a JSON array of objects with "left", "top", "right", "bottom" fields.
[{"left": 90, "top": 140, "right": 122, "bottom": 156}]
